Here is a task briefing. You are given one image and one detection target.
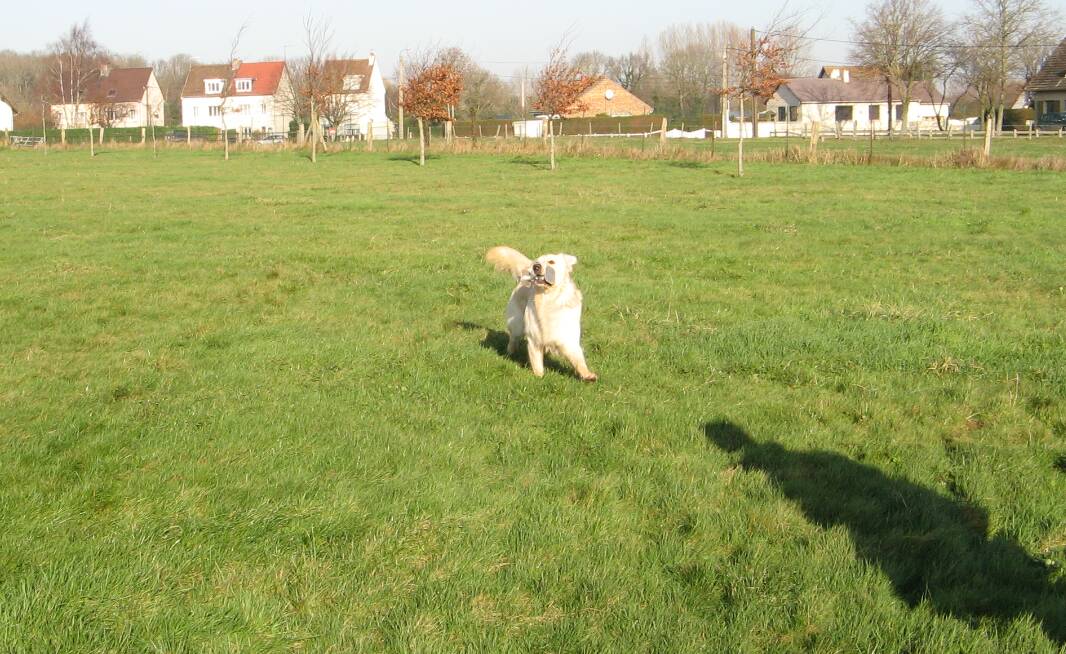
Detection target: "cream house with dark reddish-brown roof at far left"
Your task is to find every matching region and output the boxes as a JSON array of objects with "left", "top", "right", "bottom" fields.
[{"left": 51, "top": 64, "right": 164, "bottom": 129}]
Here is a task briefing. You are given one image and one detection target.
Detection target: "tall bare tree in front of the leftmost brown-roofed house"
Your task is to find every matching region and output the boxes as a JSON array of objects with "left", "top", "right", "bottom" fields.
[{"left": 49, "top": 20, "right": 107, "bottom": 127}]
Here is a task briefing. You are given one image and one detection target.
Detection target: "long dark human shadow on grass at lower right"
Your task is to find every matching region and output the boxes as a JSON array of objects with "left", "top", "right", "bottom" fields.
[{"left": 704, "top": 421, "right": 1066, "bottom": 647}]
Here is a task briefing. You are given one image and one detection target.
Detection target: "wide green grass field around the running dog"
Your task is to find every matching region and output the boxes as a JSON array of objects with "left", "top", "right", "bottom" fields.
[{"left": 0, "top": 149, "right": 1066, "bottom": 653}]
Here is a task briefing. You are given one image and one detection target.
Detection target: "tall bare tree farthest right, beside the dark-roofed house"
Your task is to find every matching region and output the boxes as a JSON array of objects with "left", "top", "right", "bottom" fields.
[{"left": 956, "top": 0, "right": 1060, "bottom": 130}]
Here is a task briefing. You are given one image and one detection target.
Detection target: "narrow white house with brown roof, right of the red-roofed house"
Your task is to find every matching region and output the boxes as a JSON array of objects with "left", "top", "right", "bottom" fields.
[{"left": 322, "top": 52, "right": 392, "bottom": 138}]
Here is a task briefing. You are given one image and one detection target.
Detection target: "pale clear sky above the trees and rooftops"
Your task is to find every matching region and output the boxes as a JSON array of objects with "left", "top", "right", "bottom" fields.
[{"left": 6, "top": 0, "right": 968, "bottom": 75}]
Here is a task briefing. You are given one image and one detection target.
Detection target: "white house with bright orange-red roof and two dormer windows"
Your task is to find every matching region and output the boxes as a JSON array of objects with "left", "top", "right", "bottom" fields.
[{"left": 181, "top": 60, "right": 292, "bottom": 135}]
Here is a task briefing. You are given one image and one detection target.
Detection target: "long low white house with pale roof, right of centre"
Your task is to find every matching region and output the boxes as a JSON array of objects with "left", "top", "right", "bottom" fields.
[{"left": 766, "top": 67, "right": 949, "bottom": 131}]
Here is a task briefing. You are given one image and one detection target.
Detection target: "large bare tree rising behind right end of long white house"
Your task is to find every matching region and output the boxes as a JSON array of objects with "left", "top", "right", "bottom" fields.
[{"left": 852, "top": 0, "right": 951, "bottom": 135}]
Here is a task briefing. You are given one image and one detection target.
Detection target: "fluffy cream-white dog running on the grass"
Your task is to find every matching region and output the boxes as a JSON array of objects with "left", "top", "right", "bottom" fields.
[{"left": 485, "top": 246, "right": 596, "bottom": 381}]
